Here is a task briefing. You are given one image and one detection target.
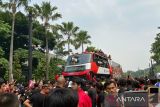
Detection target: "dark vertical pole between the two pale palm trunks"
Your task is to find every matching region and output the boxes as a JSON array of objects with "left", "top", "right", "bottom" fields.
[{"left": 28, "top": 11, "right": 32, "bottom": 82}]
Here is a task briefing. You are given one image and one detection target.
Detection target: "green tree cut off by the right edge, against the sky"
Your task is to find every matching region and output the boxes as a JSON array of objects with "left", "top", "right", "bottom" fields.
[{"left": 151, "top": 33, "right": 160, "bottom": 64}]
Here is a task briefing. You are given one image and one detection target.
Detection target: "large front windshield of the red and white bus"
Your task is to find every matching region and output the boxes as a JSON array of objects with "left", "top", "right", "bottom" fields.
[{"left": 67, "top": 54, "right": 91, "bottom": 65}]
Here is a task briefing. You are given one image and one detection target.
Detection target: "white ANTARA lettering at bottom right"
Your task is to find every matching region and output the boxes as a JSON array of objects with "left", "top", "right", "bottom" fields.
[{"left": 117, "top": 97, "right": 146, "bottom": 102}]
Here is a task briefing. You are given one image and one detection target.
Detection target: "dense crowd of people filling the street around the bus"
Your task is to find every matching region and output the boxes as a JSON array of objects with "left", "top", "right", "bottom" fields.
[{"left": 0, "top": 76, "right": 160, "bottom": 107}]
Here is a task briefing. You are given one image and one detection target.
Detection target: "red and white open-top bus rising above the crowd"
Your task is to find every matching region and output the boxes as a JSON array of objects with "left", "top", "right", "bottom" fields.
[{"left": 62, "top": 52, "right": 112, "bottom": 80}]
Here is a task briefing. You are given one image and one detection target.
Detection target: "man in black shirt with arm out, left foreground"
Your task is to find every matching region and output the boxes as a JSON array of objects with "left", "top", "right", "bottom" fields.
[{"left": 24, "top": 84, "right": 49, "bottom": 107}]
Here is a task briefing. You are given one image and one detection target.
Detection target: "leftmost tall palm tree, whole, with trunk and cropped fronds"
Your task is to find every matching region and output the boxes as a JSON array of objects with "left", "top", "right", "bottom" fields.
[{"left": 2, "top": 0, "right": 29, "bottom": 82}]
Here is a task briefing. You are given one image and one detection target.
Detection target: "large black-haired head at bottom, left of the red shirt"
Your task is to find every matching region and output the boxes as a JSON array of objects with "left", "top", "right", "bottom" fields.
[{"left": 45, "top": 88, "right": 78, "bottom": 107}]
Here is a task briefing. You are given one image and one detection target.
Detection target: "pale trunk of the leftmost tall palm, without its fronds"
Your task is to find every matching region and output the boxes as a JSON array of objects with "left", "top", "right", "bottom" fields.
[{"left": 9, "top": 13, "right": 16, "bottom": 82}]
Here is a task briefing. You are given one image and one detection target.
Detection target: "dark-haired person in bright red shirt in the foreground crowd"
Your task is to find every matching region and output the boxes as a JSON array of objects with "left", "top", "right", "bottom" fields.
[{"left": 72, "top": 77, "right": 92, "bottom": 107}]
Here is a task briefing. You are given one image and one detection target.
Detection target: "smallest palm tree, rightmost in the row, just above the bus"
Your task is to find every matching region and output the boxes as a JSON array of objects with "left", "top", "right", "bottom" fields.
[{"left": 74, "top": 31, "right": 91, "bottom": 52}]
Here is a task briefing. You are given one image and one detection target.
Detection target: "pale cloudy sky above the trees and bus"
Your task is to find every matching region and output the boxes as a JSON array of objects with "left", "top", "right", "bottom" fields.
[{"left": 32, "top": 0, "right": 160, "bottom": 71}]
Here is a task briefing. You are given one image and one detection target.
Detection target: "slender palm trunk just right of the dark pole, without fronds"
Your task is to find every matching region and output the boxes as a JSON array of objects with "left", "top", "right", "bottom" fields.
[{"left": 45, "top": 27, "right": 49, "bottom": 80}]
